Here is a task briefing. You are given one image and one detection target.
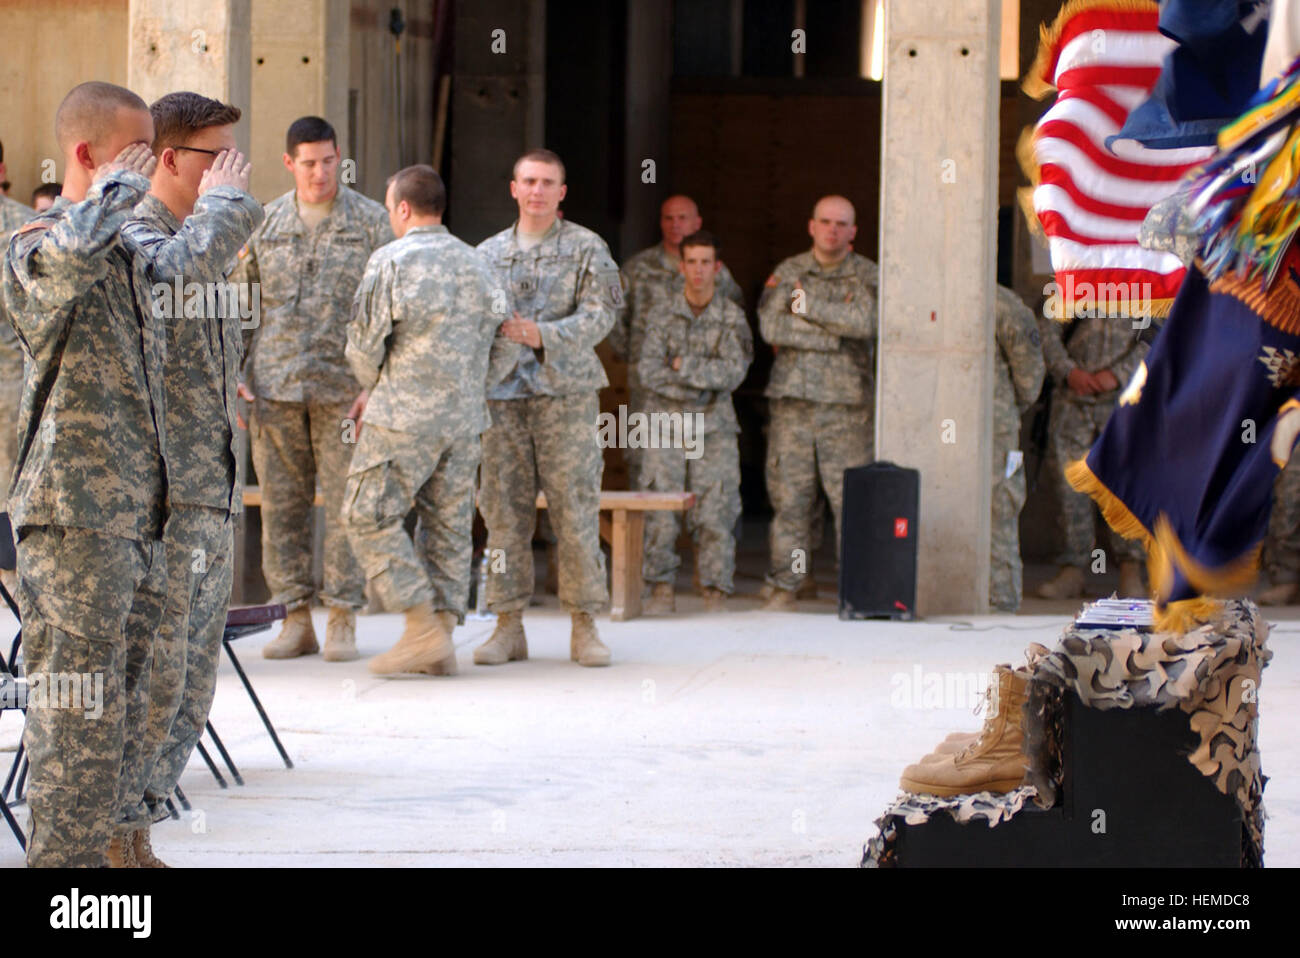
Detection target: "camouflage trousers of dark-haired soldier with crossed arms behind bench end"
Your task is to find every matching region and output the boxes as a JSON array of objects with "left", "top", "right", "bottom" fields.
[{"left": 640, "top": 432, "right": 740, "bottom": 595}]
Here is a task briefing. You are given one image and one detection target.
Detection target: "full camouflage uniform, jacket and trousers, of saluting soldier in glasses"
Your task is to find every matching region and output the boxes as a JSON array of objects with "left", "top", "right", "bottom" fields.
[{"left": 122, "top": 186, "right": 263, "bottom": 820}]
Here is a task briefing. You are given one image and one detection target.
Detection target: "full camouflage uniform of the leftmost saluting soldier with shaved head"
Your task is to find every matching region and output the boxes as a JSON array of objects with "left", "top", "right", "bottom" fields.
[{"left": 4, "top": 170, "right": 166, "bottom": 867}]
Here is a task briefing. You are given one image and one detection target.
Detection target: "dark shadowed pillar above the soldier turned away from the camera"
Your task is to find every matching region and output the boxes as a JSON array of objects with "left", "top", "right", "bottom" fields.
[{"left": 447, "top": 0, "right": 546, "bottom": 243}]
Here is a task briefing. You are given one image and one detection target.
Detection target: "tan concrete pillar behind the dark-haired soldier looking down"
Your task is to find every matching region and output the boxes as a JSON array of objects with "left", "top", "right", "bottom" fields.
[{"left": 250, "top": 0, "right": 358, "bottom": 203}]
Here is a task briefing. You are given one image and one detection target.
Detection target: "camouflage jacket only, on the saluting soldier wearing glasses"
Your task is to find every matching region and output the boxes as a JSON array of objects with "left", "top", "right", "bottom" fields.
[{"left": 122, "top": 186, "right": 263, "bottom": 513}]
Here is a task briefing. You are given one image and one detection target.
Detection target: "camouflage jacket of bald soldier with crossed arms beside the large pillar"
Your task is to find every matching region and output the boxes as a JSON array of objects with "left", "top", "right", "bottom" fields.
[{"left": 758, "top": 250, "right": 879, "bottom": 406}]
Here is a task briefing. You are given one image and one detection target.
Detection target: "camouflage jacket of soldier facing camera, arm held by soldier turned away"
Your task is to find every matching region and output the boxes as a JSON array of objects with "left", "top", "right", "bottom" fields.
[{"left": 478, "top": 220, "right": 623, "bottom": 399}]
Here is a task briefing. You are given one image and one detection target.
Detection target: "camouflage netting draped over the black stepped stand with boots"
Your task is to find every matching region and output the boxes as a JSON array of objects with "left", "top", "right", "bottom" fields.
[{"left": 862, "top": 599, "right": 1273, "bottom": 867}]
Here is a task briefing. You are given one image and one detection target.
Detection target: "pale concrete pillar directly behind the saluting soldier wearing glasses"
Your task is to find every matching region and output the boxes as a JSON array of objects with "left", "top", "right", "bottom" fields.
[{"left": 126, "top": 0, "right": 252, "bottom": 153}]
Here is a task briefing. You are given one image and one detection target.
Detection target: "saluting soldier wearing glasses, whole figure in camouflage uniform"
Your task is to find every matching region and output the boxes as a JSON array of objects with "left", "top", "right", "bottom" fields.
[{"left": 122, "top": 94, "right": 263, "bottom": 867}]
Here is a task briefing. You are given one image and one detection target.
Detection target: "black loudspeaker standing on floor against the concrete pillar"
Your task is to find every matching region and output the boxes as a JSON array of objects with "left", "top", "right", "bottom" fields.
[{"left": 840, "top": 463, "right": 920, "bottom": 619}]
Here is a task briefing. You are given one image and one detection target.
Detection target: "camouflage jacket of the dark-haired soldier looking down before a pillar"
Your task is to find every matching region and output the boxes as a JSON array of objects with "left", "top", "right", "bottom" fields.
[{"left": 230, "top": 185, "right": 393, "bottom": 403}]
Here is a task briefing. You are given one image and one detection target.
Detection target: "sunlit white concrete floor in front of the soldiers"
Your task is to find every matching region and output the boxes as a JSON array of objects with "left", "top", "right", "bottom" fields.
[{"left": 0, "top": 597, "right": 1300, "bottom": 867}]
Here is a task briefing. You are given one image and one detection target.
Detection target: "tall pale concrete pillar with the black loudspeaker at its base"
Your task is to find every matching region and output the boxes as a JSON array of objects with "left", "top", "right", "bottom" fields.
[{"left": 876, "top": 0, "right": 1001, "bottom": 615}]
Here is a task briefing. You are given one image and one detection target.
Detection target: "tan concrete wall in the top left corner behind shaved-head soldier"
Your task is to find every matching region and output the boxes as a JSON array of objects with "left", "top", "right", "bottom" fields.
[{"left": 0, "top": 0, "right": 129, "bottom": 203}]
